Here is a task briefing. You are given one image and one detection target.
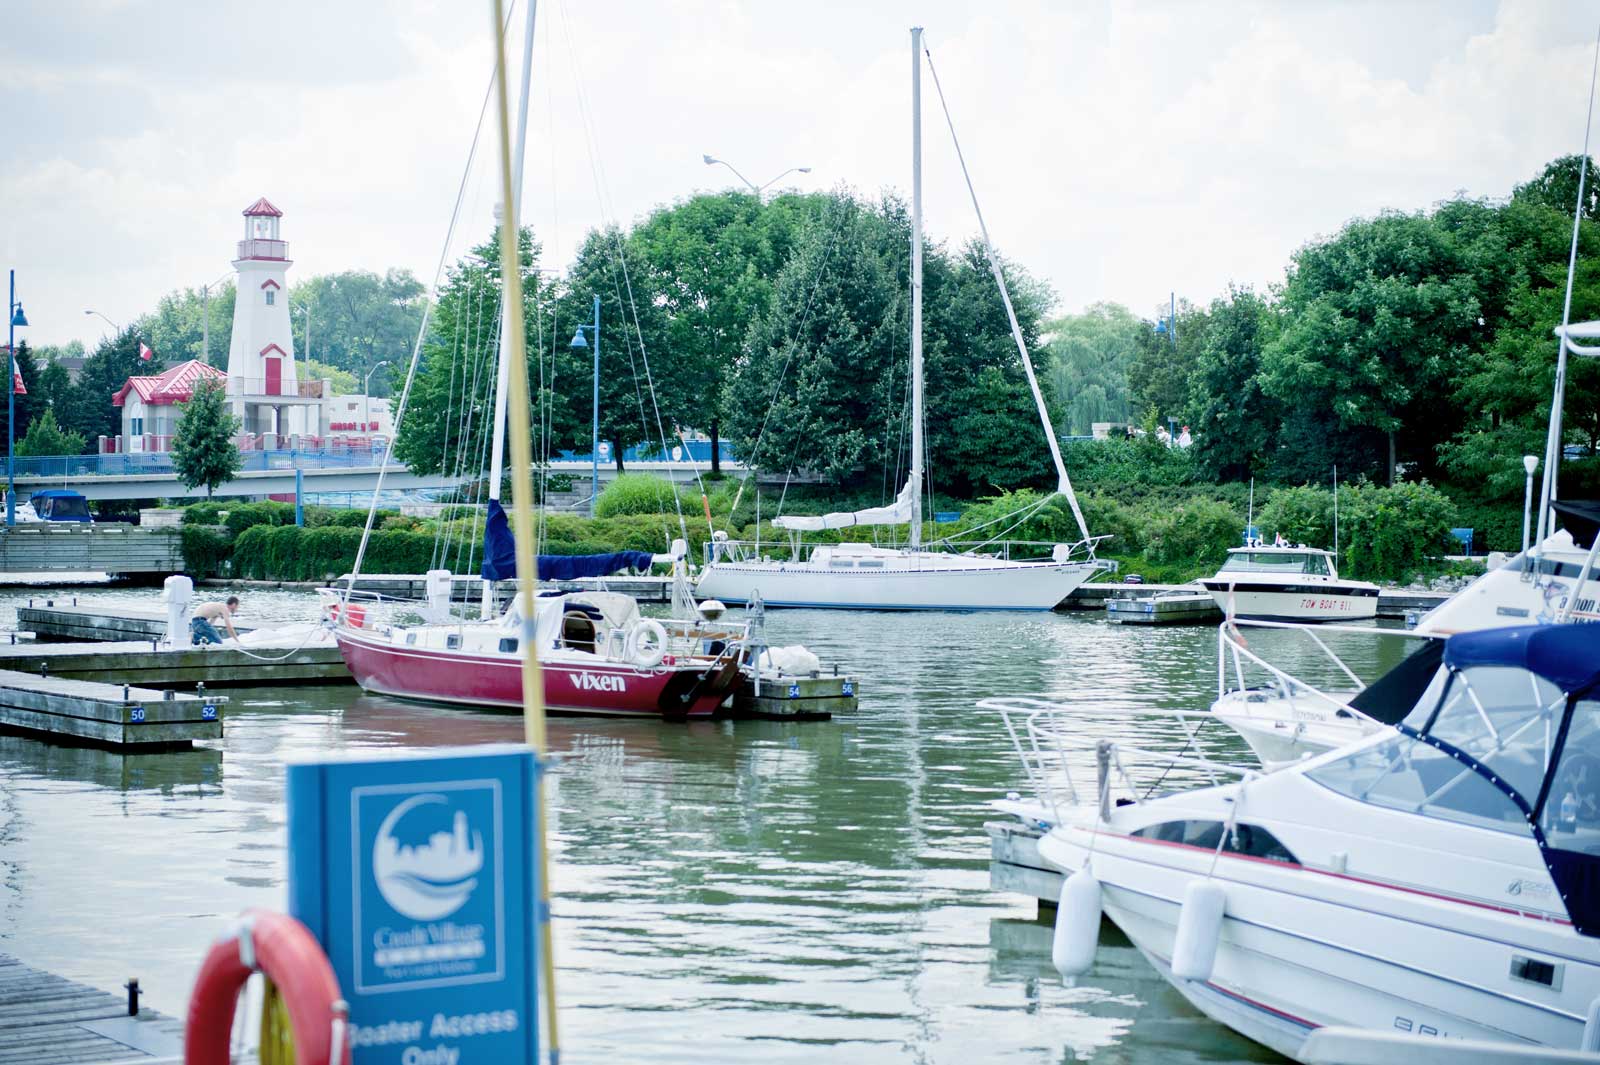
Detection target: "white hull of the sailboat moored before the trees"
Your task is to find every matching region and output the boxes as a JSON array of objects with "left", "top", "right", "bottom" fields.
[{"left": 694, "top": 560, "right": 1098, "bottom": 611}]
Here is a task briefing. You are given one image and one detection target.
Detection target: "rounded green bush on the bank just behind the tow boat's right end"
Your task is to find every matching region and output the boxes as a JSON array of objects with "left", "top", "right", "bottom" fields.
[{"left": 1339, "top": 481, "right": 1454, "bottom": 580}]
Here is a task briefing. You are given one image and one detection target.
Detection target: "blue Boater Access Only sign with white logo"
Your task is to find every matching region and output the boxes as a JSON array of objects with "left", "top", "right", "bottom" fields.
[{"left": 288, "top": 747, "right": 539, "bottom": 1065}]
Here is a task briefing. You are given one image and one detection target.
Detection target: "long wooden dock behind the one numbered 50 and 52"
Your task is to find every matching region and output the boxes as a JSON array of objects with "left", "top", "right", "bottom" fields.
[{"left": 0, "top": 640, "right": 344, "bottom": 689}]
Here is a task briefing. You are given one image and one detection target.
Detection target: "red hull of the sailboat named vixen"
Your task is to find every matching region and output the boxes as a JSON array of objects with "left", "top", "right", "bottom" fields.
[{"left": 338, "top": 628, "right": 738, "bottom": 718}]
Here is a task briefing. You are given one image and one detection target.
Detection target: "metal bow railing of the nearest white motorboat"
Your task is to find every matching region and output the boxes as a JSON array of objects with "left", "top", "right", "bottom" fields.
[{"left": 978, "top": 697, "right": 1259, "bottom": 822}]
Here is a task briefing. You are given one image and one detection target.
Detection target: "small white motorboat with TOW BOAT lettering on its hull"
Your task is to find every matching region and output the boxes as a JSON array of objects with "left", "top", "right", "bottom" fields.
[{"left": 1200, "top": 544, "right": 1378, "bottom": 622}]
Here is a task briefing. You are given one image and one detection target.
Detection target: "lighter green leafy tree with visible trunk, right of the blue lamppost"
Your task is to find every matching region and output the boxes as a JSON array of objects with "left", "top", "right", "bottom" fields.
[{"left": 627, "top": 190, "right": 826, "bottom": 472}]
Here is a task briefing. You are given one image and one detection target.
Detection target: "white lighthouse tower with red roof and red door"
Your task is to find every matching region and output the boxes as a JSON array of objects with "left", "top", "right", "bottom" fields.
[{"left": 227, "top": 197, "right": 318, "bottom": 448}]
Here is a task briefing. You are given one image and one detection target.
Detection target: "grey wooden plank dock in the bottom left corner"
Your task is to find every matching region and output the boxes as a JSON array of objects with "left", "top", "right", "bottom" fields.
[{"left": 0, "top": 955, "right": 184, "bottom": 1065}]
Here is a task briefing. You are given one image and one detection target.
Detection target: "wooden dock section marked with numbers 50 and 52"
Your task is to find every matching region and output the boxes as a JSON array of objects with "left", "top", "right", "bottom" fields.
[{"left": 0, "top": 670, "right": 227, "bottom": 750}]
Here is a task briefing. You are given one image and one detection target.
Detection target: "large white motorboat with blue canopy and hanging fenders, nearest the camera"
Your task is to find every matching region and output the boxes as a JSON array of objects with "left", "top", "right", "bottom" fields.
[{"left": 984, "top": 624, "right": 1600, "bottom": 1060}]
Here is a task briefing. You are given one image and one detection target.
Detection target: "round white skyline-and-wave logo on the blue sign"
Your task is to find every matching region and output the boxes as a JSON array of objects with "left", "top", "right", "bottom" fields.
[{"left": 373, "top": 792, "right": 483, "bottom": 921}]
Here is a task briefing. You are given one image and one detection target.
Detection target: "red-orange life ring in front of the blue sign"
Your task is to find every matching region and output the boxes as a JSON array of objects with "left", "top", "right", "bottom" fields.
[{"left": 184, "top": 910, "right": 349, "bottom": 1065}]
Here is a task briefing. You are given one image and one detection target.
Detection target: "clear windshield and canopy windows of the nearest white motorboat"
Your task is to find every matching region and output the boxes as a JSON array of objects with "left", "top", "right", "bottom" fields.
[{"left": 1307, "top": 667, "right": 1568, "bottom": 835}]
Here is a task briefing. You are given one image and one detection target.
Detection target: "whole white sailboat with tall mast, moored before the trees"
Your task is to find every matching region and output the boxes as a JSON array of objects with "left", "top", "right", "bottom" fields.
[{"left": 696, "top": 27, "right": 1102, "bottom": 611}]
